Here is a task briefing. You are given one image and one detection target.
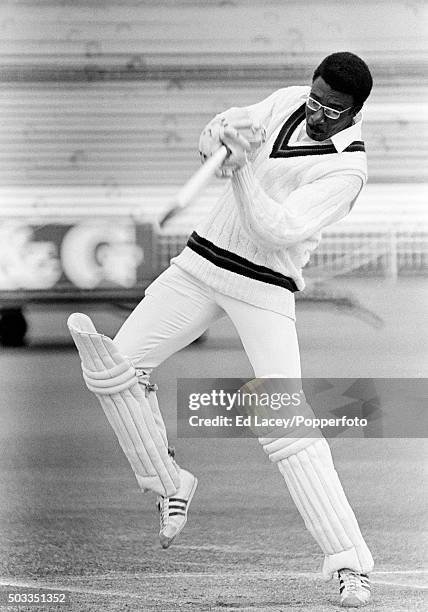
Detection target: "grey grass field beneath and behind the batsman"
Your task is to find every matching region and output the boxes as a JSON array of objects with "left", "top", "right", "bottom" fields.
[{"left": 0, "top": 280, "right": 428, "bottom": 612}]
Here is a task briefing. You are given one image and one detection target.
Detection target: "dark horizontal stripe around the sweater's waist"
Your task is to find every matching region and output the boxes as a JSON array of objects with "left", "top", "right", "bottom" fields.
[{"left": 187, "top": 232, "right": 299, "bottom": 293}]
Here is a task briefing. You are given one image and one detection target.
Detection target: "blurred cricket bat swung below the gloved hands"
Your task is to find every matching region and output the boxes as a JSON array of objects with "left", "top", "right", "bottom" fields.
[{"left": 159, "top": 145, "right": 229, "bottom": 227}]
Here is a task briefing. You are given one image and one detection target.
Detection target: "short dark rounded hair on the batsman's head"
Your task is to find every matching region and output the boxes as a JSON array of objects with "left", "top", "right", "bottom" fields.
[{"left": 312, "top": 51, "right": 373, "bottom": 111}]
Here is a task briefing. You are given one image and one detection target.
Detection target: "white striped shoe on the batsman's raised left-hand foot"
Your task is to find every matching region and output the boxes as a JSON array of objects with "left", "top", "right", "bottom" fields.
[{"left": 157, "top": 468, "right": 198, "bottom": 548}]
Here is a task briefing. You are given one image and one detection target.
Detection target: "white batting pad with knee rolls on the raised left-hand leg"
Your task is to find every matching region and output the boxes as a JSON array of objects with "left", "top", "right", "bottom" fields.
[{"left": 67, "top": 313, "right": 180, "bottom": 497}]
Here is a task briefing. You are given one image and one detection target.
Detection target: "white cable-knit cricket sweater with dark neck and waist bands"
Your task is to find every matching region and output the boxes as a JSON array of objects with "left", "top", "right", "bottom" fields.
[{"left": 171, "top": 87, "right": 367, "bottom": 318}]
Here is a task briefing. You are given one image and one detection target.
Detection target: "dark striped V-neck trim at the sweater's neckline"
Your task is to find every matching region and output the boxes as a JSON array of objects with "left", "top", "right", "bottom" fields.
[{"left": 269, "top": 103, "right": 365, "bottom": 157}]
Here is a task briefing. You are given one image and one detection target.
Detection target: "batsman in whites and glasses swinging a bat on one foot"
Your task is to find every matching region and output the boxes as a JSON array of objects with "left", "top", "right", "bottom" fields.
[{"left": 69, "top": 52, "right": 373, "bottom": 607}]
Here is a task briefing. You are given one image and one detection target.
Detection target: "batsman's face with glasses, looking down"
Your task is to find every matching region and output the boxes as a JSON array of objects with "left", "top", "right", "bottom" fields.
[{"left": 306, "top": 77, "right": 355, "bottom": 141}]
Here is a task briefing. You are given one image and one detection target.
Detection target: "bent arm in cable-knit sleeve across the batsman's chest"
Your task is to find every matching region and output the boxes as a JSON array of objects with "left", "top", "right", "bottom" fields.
[{"left": 232, "top": 164, "right": 363, "bottom": 249}]
